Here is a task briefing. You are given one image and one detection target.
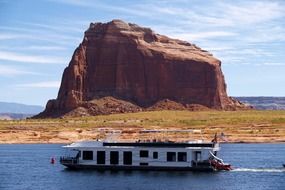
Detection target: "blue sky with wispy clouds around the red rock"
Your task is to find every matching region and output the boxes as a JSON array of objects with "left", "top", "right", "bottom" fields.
[{"left": 0, "top": 0, "right": 285, "bottom": 106}]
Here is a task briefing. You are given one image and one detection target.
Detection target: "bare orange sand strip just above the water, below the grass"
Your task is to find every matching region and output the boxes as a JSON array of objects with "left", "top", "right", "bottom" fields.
[{"left": 0, "top": 130, "right": 285, "bottom": 144}]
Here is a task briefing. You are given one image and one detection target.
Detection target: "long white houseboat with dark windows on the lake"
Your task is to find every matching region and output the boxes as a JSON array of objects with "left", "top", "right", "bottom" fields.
[{"left": 60, "top": 130, "right": 231, "bottom": 171}]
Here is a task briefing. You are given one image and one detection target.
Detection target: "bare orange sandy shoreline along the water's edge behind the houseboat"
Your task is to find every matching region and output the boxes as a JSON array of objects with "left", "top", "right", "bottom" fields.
[{"left": 0, "top": 127, "right": 285, "bottom": 144}]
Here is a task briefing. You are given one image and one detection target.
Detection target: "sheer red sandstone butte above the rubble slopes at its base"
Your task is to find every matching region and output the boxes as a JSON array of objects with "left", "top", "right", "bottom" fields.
[{"left": 35, "top": 20, "right": 246, "bottom": 117}]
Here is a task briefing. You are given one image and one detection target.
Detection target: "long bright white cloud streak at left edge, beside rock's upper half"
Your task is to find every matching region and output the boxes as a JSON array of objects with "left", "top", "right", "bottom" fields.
[{"left": 0, "top": 51, "right": 67, "bottom": 64}]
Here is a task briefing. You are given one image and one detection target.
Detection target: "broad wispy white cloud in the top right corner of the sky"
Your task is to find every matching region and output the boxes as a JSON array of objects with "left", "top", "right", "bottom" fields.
[{"left": 153, "top": 1, "right": 285, "bottom": 28}]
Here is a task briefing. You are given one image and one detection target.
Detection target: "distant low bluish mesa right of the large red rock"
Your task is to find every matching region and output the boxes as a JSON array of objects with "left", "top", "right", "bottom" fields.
[{"left": 235, "top": 96, "right": 285, "bottom": 110}]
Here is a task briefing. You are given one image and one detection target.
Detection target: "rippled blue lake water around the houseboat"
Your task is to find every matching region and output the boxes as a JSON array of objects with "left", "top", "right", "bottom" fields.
[{"left": 0, "top": 144, "right": 285, "bottom": 190}]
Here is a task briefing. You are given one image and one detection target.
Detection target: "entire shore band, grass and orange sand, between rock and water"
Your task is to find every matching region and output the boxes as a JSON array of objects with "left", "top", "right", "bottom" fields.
[{"left": 0, "top": 111, "right": 285, "bottom": 144}]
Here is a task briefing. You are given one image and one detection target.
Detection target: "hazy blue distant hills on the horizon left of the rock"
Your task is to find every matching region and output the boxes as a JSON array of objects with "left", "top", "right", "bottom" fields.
[{"left": 0, "top": 102, "right": 44, "bottom": 120}]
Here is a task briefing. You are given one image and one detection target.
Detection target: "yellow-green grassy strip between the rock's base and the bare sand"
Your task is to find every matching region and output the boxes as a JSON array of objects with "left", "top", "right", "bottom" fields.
[{"left": 0, "top": 111, "right": 285, "bottom": 129}]
